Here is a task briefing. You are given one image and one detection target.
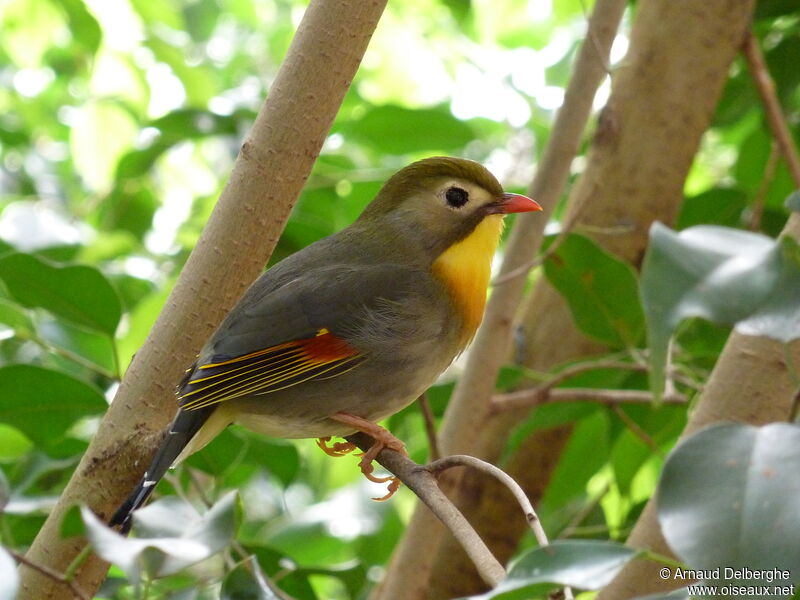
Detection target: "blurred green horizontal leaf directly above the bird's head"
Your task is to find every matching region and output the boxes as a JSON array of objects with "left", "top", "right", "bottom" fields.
[{"left": 339, "top": 105, "right": 475, "bottom": 154}]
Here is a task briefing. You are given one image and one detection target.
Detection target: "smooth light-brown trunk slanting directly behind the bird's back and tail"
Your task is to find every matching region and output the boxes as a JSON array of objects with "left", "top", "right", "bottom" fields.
[{"left": 14, "top": 0, "right": 386, "bottom": 600}]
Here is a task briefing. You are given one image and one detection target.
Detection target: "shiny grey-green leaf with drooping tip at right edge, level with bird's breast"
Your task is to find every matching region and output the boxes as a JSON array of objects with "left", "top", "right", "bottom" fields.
[{"left": 641, "top": 223, "right": 800, "bottom": 395}]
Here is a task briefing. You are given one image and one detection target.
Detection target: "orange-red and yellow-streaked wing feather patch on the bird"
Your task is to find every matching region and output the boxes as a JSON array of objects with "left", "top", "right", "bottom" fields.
[{"left": 178, "top": 329, "right": 363, "bottom": 410}]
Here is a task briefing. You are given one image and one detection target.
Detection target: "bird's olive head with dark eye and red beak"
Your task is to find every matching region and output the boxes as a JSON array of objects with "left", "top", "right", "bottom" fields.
[{"left": 359, "top": 156, "right": 542, "bottom": 257}]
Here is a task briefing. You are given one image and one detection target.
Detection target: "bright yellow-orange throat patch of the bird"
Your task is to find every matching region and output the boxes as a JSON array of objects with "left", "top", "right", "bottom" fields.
[{"left": 433, "top": 215, "right": 503, "bottom": 345}]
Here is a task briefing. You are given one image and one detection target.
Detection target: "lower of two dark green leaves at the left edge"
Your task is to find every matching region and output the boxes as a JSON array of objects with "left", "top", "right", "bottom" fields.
[{"left": 0, "top": 365, "right": 108, "bottom": 449}]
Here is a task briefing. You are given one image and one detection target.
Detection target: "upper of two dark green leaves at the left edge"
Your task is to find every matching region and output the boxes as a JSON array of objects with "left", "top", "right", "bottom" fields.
[{"left": 0, "top": 253, "right": 122, "bottom": 336}]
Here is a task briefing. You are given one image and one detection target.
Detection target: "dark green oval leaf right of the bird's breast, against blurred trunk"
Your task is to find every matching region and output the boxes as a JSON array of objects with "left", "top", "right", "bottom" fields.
[{"left": 544, "top": 234, "right": 644, "bottom": 347}]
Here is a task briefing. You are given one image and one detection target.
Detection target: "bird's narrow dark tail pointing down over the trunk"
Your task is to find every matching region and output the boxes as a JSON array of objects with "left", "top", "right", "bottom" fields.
[{"left": 108, "top": 406, "right": 216, "bottom": 534}]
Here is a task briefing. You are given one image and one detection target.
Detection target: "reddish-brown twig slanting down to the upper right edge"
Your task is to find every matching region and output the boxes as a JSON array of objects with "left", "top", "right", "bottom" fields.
[{"left": 742, "top": 31, "right": 800, "bottom": 188}]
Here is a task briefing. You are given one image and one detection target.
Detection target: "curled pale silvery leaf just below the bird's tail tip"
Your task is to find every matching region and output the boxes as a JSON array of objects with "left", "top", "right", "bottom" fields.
[{"left": 87, "top": 492, "right": 237, "bottom": 582}]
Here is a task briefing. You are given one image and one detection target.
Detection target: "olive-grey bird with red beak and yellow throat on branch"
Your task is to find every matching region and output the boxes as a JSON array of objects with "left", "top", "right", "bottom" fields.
[{"left": 109, "top": 156, "right": 542, "bottom": 533}]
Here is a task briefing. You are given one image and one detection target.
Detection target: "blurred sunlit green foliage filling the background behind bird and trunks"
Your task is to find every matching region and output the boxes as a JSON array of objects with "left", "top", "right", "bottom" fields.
[{"left": 0, "top": 0, "right": 800, "bottom": 599}]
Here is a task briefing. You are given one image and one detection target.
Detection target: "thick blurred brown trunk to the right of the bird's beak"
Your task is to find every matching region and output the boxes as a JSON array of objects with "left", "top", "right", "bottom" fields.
[{"left": 426, "top": 0, "right": 753, "bottom": 599}]
